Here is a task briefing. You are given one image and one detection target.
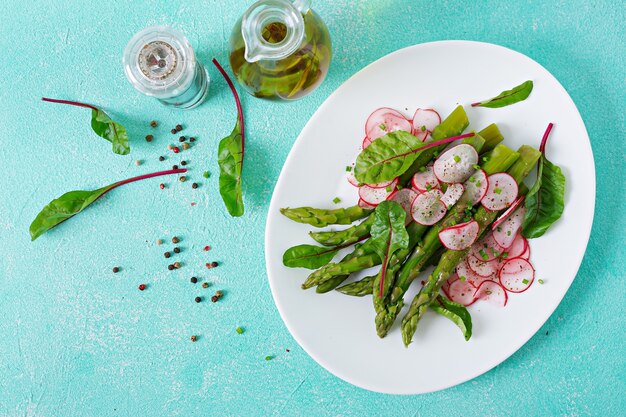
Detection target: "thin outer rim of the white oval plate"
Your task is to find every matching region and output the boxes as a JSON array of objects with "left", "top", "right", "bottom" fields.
[{"left": 264, "top": 39, "right": 597, "bottom": 395}]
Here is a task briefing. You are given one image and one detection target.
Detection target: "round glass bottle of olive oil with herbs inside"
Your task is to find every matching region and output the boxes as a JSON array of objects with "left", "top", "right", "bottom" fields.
[{"left": 230, "top": 0, "right": 332, "bottom": 100}]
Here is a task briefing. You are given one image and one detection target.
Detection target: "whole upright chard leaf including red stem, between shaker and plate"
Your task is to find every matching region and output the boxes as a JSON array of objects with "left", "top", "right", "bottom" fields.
[{"left": 213, "top": 58, "right": 245, "bottom": 217}]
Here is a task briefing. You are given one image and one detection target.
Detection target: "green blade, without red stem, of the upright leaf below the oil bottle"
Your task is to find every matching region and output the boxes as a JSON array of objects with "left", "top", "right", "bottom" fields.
[{"left": 217, "top": 118, "right": 243, "bottom": 217}]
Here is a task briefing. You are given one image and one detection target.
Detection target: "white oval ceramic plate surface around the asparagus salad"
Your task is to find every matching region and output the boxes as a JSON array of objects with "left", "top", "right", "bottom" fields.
[{"left": 265, "top": 41, "right": 595, "bottom": 394}]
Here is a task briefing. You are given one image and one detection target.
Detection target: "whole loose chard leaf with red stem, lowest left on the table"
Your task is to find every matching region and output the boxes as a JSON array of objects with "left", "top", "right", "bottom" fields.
[{"left": 30, "top": 168, "right": 187, "bottom": 240}]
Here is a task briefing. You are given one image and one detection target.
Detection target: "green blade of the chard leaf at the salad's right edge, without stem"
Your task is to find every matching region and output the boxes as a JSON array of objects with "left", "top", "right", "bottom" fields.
[{"left": 522, "top": 156, "right": 565, "bottom": 239}]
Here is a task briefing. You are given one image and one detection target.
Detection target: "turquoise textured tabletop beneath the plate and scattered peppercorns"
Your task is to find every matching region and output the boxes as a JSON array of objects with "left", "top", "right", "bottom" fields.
[{"left": 0, "top": 0, "right": 626, "bottom": 417}]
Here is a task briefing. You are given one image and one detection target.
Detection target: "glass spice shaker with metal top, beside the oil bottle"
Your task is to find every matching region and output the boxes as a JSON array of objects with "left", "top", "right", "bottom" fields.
[{"left": 122, "top": 26, "right": 209, "bottom": 109}]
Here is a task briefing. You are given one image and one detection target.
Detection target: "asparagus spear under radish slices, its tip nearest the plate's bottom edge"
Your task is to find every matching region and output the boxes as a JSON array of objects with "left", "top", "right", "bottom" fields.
[{"left": 402, "top": 145, "right": 541, "bottom": 346}]
